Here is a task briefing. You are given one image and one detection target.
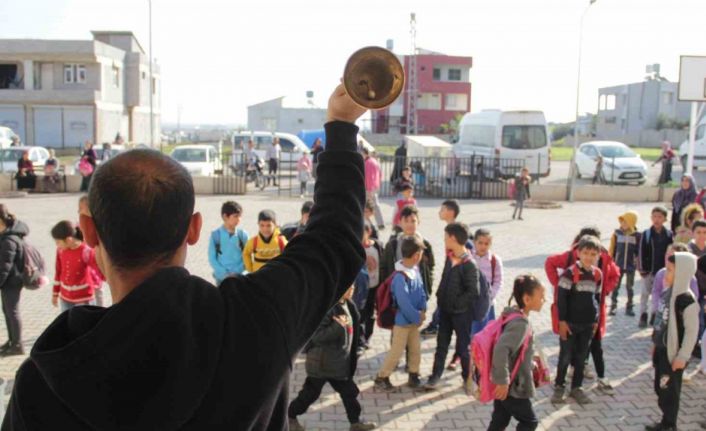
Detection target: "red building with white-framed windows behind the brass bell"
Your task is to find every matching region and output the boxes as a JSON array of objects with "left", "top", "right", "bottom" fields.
[{"left": 372, "top": 49, "right": 473, "bottom": 134}]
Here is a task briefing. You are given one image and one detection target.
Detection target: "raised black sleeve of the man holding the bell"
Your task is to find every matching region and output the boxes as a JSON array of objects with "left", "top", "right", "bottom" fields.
[{"left": 221, "top": 122, "right": 365, "bottom": 358}]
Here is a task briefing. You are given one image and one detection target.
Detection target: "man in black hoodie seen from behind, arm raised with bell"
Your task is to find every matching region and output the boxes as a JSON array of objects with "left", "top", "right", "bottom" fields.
[{"left": 2, "top": 86, "right": 365, "bottom": 431}]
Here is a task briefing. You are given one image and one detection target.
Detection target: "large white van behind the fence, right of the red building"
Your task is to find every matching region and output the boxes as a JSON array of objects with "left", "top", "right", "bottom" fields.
[{"left": 454, "top": 109, "right": 551, "bottom": 177}]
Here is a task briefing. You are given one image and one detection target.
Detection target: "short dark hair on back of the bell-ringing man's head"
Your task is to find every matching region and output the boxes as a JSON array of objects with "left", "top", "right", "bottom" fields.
[{"left": 88, "top": 149, "right": 195, "bottom": 269}]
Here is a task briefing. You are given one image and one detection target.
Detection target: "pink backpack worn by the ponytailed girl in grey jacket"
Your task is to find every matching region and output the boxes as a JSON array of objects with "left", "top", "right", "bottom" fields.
[{"left": 470, "top": 312, "right": 532, "bottom": 403}]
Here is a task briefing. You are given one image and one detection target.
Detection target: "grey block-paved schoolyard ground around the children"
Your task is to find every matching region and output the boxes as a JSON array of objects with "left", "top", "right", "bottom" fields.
[{"left": 0, "top": 194, "right": 706, "bottom": 431}]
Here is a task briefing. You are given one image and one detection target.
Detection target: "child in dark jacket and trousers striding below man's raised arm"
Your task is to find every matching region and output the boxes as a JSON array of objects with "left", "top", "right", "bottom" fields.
[{"left": 287, "top": 287, "right": 376, "bottom": 431}]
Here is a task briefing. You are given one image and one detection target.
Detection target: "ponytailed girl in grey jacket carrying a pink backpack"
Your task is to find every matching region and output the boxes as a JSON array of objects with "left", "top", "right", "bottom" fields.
[{"left": 484, "top": 275, "right": 544, "bottom": 431}]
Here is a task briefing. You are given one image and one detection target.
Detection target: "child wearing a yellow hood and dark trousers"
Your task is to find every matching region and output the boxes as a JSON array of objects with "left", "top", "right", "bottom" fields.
[{"left": 609, "top": 211, "right": 640, "bottom": 316}]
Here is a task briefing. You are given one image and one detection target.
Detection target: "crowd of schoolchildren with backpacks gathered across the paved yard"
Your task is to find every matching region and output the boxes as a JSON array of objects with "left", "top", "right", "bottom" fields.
[{"left": 45, "top": 194, "right": 706, "bottom": 431}]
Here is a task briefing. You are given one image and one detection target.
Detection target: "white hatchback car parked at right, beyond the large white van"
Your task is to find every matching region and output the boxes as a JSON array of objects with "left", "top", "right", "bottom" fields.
[{"left": 575, "top": 141, "right": 647, "bottom": 185}]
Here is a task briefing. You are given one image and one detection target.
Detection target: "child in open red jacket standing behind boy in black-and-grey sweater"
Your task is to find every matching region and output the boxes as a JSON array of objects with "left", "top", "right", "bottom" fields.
[{"left": 544, "top": 226, "right": 620, "bottom": 395}]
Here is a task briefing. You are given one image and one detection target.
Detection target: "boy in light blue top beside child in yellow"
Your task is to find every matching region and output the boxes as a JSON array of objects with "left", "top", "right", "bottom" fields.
[{"left": 208, "top": 201, "right": 248, "bottom": 285}]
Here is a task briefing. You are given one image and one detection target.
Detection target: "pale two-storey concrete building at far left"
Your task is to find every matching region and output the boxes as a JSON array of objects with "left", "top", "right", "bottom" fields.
[{"left": 0, "top": 31, "right": 161, "bottom": 148}]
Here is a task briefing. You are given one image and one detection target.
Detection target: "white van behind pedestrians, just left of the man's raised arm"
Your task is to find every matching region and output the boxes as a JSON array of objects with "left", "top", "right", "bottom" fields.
[{"left": 231, "top": 131, "right": 309, "bottom": 170}]
